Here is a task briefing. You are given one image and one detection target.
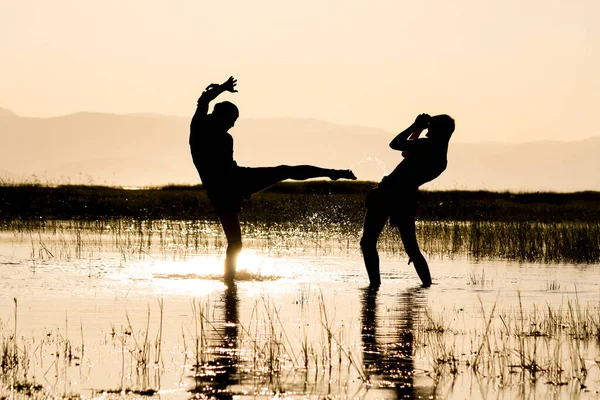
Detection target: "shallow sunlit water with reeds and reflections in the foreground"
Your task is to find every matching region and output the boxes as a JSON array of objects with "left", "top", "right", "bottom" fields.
[{"left": 0, "top": 223, "right": 600, "bottom": 399}]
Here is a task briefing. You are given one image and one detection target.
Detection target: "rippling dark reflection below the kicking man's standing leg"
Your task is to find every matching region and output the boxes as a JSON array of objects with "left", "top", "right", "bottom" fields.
[{"left": 190, "top": 284, "right": 240, "bottom": 399}]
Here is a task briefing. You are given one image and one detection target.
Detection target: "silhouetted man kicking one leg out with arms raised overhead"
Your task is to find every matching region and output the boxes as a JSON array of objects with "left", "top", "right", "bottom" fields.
[{"left": 190, "top": 77, "right": 356, "bottom": 284}]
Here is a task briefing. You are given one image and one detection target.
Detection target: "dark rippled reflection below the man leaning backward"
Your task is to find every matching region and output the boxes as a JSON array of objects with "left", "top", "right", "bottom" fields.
[{"left": 361, "top": 286, "right": 433, "bottom": 399}]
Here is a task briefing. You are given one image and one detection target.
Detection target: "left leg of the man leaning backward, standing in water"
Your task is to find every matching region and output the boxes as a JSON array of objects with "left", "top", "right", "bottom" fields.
[{"left": 360, "top": 208, "right": 388, "bottom": 286}]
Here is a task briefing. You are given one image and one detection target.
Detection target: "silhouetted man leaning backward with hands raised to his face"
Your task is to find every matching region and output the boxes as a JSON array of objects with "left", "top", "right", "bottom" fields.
[{"left": 360, "top": 114, "right": 454, "bottom": 286}]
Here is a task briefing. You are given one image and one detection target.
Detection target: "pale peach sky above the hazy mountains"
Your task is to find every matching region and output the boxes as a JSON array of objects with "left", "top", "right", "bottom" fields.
[{"left": 0, "top": 0, "right": 600, "bottom": 142}]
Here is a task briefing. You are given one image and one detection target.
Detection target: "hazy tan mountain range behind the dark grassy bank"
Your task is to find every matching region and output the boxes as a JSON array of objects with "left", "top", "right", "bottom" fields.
[{"left": 0, "top": 108, "right": 600, "bottom": 191}]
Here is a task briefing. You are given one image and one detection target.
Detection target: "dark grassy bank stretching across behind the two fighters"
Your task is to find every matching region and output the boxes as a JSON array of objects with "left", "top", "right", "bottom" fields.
[{"left": 0, "top": 181, "right": 600, "bottom": 223}]
